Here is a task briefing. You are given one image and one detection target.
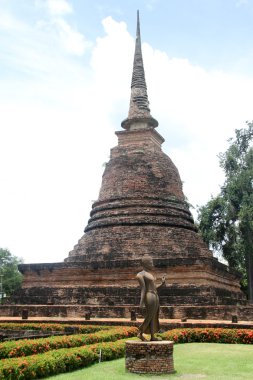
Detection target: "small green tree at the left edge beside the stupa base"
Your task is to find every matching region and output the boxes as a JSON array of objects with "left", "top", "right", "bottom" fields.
[{"left": 0, "top": 248, "right": 22, "bottom": 296}]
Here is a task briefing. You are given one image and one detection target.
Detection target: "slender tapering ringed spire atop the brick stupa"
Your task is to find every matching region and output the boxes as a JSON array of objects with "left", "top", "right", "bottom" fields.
[{"left": 121, "top": 11, "right": 158, "bottom": 130}]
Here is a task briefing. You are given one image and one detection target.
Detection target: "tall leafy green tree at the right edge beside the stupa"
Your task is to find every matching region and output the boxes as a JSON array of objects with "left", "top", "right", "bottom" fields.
[{"left": 198, "top": 122, "right": 253, "bottom": 303}]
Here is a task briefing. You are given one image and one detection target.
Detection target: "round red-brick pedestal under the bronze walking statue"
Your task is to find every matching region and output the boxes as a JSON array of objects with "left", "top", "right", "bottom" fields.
[{"left": 126, "top": 340, "right": 175, "bottom": 374}]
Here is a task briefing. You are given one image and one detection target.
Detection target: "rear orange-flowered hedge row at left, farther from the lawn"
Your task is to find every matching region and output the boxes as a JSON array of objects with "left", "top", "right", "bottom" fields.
[{"left": 0, "top": 327, "right": 138, "bottom": 359}]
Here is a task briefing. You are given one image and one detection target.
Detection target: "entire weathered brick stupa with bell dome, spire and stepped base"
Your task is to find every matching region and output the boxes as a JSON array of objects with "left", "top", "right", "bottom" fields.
[{"left": 2, "top": 12, "right": 253, "bottom": 320}]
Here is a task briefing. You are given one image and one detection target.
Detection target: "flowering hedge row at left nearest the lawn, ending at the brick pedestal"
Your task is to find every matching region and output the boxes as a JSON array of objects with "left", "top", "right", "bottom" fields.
[{"left": 0, "top": 340, "right": 125, "bottom": 380}]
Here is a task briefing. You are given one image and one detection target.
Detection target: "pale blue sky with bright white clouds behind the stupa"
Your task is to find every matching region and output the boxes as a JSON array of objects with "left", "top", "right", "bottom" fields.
[{"left": 0, "top": 0, "right": 253, "bottom": 263}]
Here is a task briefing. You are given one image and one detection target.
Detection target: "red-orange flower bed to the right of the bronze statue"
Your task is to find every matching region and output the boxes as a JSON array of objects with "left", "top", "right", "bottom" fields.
[{"left": 160, "top": 328, "right": 253, "bottom": 344}]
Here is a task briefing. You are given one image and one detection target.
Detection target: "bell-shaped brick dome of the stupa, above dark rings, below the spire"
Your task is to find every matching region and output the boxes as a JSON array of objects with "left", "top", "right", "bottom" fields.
[{"left": 98, "top": 130, "right": 184, "bottom": 201}]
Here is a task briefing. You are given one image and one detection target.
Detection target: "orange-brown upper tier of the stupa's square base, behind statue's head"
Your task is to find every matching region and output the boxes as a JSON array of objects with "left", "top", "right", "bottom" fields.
[{"left": 19, "top": 255, "right": 243, "bottom": 297}]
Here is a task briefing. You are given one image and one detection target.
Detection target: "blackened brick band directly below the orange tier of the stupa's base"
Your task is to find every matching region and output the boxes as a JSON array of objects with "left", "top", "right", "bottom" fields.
[{"left": 12, "top": 284, "right": 246, "bottom": 306}]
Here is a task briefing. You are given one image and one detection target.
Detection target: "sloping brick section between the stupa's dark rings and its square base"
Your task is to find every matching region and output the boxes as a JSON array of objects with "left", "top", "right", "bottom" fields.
[{"left": 65, "top": 223, "right": 212, "bottom": 265}]
